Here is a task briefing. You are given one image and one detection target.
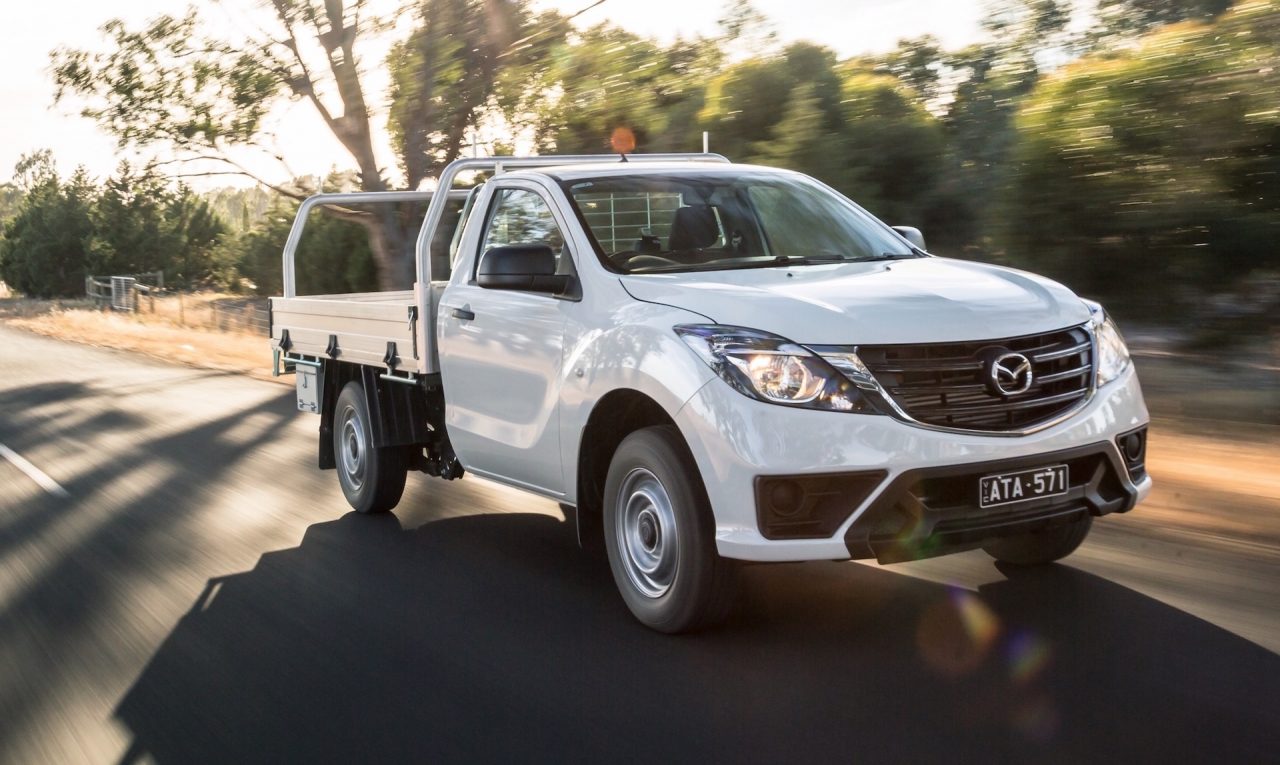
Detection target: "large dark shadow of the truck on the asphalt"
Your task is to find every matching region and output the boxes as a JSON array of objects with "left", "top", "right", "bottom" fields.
[{"left": 116, "top": 514, "right": 1280, "bottom": 762}]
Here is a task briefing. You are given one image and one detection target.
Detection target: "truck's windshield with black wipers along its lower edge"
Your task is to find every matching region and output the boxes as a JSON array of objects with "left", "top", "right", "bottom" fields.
[{"left": 561, "top": 171, "right": 918, "bottom": 274}]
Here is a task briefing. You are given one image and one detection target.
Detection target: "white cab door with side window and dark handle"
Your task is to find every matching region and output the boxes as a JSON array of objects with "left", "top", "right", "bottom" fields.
[{"left": 436, "top": 182, "right": 577, "bottom": 495}]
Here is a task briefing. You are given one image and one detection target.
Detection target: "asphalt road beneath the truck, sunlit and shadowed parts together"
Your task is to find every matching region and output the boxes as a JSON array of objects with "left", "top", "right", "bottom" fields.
[{"left": 0, "top": 326, "right": 1280, "bottom": 762}]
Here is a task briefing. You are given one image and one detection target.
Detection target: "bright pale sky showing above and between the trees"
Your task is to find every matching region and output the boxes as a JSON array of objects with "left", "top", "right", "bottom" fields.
[{"left": 0, "top": 0, "right": 983, "bottom": 188}]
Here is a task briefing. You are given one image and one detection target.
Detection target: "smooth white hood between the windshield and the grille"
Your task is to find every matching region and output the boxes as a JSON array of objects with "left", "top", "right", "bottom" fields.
[{"left": 622, "top": 257, "right": 1089, "bottom": 345}]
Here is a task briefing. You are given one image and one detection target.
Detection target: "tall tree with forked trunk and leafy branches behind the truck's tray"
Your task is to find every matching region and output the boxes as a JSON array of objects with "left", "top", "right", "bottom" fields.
[{"left": 52, "top": 0, "right": 550, "bottom": 288}]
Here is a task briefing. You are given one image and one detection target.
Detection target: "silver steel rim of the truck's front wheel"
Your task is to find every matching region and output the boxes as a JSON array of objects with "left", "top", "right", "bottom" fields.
[{"left": 617, "top": 467, "right": 680, "bottom": 599}]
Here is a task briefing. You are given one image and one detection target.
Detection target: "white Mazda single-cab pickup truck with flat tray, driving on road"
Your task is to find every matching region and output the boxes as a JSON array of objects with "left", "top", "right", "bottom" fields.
[{"left": 271, "top": 155, "right": 1151, "bottom": 632}]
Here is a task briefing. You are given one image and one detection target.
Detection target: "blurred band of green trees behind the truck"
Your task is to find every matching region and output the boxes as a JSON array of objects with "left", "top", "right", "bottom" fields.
[{"left": 0, "top": 0, "right": 1280, "bottom": 332}]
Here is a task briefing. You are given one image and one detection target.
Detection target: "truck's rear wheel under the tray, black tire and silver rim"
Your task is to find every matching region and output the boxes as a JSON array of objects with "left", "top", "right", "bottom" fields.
[{"left": 333, "top": 381, "right": 407, "bottom": 513}]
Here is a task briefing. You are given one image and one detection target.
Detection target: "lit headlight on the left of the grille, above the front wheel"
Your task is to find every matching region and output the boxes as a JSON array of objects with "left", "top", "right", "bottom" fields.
[{"left": 675, "top": 324, "right": 873, "bottom": 412}]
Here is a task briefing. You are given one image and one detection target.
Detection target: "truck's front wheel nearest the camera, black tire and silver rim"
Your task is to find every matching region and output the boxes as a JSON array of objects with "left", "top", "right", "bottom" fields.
[{"left": 603, "top": 426, "right": 739, "bottom": 633}]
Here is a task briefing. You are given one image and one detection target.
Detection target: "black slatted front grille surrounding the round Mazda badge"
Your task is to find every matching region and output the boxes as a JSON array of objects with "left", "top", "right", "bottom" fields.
[{"left": 858, "top": 326, "right": 1093, "bottom": 432}]
